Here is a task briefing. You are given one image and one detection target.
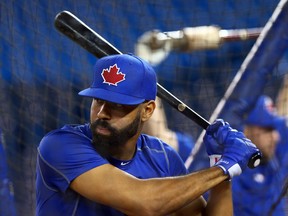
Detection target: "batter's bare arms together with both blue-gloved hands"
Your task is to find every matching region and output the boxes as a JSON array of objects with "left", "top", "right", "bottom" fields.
[{"left": 70, "top": 121, "right": 259, "bottom": 215}]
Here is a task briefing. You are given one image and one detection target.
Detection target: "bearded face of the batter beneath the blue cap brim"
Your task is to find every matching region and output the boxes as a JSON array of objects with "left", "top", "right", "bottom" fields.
[{"left": 90, "top": 99, "right": 141, "bottom": 147}]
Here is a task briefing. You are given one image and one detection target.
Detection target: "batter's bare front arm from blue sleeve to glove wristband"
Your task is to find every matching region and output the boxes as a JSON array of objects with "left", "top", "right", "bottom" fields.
[{"left": 70, "top": 164, "right": 227, "bottom": 215}]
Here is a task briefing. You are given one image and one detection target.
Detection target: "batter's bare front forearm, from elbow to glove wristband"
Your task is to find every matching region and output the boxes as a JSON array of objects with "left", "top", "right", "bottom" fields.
[{"left": 137, "top": 167, "right": 227, "bottom": 215}]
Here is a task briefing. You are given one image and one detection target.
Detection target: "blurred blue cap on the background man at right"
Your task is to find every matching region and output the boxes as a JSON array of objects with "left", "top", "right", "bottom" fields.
[{"left": 245, "top": 95, "right": 281, "bottom": 129}]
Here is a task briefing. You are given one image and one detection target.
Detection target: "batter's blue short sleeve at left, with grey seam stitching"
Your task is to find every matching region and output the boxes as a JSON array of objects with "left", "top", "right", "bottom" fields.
[{"left": 38, "top": 131, "right": 108, "bottom": 191}]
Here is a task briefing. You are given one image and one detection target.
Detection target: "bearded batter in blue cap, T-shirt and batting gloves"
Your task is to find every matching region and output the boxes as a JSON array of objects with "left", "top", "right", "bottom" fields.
[{"left": 36, "top": 54, "right": 259, "bottom": 216}]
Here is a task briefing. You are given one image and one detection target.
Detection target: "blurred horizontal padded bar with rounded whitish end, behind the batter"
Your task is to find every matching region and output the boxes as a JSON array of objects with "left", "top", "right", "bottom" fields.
[{"left": 135, "top": 25, "right": 262, "bottom": 66}]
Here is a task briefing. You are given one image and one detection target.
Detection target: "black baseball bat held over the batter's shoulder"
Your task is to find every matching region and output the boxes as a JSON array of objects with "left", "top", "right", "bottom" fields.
[{"left": 54, "top": 11, "right": 259, "bottom": 168}]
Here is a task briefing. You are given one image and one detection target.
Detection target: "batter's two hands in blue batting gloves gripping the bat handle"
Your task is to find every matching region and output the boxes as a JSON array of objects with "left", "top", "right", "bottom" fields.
[{"left": 203, "top": 119, "right": 260, "bottom": 178}]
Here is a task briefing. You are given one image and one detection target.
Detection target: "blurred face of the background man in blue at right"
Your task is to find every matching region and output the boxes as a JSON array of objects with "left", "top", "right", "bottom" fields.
[{"left": 244, "top": 125, "right": 280, "bottom": 160}]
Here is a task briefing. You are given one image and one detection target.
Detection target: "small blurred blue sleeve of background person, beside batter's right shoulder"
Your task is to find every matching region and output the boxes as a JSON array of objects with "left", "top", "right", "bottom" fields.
[{"left": 176, "top": 132, "right": 194, "bottom": 161}]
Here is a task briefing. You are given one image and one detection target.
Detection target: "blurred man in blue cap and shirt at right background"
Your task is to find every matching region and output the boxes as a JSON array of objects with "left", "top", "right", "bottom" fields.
[{"left": 232, "top": 95, "right": 288, "bottom": 216}]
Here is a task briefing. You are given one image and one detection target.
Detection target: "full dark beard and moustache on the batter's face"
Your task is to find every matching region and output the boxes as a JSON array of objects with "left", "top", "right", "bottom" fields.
[{"left": 90, "top": 113, "right": 140, "bottom": 157}]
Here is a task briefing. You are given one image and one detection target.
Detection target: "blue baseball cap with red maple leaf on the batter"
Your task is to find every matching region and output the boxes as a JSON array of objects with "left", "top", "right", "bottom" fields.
[{"left": 79, "top": 54, "right": 157, "bottom": 105}]
